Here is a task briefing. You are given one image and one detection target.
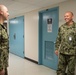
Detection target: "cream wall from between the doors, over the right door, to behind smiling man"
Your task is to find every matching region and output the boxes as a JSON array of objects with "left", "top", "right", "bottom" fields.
[{"left": 25, "top": 0, "right": 76, "bottom": 61}]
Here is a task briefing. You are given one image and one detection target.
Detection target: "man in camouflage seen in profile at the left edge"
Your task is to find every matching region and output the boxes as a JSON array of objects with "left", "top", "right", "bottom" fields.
[{"left": 0, "top": 5, "right": 9, "bottom": 75}]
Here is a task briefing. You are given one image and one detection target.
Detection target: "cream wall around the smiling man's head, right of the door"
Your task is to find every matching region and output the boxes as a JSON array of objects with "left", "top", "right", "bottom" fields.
[{"left": 59, "top": 0, "right": 76, "bottom": 25}]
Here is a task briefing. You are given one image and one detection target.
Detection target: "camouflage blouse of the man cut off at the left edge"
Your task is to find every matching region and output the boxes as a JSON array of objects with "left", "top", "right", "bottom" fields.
[{"left": 0, "top": 24, "right": 9, "bottom": 70}]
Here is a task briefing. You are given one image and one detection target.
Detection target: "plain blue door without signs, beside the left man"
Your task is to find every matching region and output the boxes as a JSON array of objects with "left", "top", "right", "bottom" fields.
[{"left": 9, "top": 16, "right": 24, "bottom": 57}]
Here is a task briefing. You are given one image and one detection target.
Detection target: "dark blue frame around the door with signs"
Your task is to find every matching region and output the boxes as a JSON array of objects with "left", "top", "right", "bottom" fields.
[{"left": 38, "top": 7, "right": 59, "bottom": 65}]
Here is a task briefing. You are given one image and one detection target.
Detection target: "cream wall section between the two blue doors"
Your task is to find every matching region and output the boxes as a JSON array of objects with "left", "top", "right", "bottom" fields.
[{"left": 25, "top": 11, "right": 38, "bottom": 61}]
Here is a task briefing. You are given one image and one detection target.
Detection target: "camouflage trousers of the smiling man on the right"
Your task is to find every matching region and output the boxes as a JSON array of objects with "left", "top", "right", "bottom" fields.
[{"left": 57, "top": 53, "right": 76, "bottom": 75}]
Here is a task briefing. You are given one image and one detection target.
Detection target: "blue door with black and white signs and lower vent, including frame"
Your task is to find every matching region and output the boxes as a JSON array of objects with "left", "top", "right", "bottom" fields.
[{"left": 39, "top": 7, "right": 59, "bottom": 70}]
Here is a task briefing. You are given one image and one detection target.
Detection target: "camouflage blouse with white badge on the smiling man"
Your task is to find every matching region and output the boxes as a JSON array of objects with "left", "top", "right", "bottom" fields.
[{"left": 55, "top": 22, "right": 76, "bottom": 55}]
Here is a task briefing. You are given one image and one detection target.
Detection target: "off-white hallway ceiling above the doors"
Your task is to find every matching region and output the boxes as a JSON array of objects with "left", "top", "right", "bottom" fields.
[{"left": 0, "top": 0, "right": 66, "bottom": 17}]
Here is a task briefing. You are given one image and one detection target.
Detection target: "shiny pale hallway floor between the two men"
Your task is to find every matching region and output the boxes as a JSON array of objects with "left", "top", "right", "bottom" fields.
[{"left": 8, "top": 53, "right": 56, "bottom": 75}]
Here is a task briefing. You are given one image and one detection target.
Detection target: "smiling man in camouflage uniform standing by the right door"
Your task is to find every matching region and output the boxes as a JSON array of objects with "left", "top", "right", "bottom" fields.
[{"left": 55, "top": 11, "right": 76, "bottom": 75}]
